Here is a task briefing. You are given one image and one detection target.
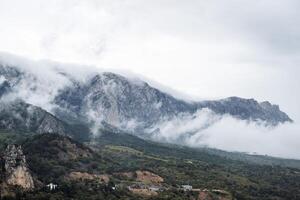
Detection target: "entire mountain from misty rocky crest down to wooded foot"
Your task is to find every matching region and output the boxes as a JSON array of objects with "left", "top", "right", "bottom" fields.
[{"left": 0, "top": 54, "right": 300, "bottom": 200}]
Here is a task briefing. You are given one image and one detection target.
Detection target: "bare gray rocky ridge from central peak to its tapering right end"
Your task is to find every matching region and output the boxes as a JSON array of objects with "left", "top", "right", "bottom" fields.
[{"left": 55, "top": 73, "right": 292, "bottom": 131}]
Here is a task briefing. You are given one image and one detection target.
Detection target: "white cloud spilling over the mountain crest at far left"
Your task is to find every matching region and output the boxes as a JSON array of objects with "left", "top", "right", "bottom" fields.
[{"left": 0, "top": 52, "right": 100, "bottom": 112}]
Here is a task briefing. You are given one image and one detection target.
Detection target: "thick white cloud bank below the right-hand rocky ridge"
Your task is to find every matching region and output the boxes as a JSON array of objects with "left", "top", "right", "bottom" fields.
[{"left": 152, "top": 110, "right": 300, "bottom": 159}]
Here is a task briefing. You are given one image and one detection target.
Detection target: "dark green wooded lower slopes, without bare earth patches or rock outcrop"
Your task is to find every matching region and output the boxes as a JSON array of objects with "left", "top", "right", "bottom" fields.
[{"left": 0, "top": 132, "right": 300, "bottom": 200}]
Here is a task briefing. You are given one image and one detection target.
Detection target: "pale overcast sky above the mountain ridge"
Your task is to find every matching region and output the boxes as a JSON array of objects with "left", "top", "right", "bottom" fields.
[{"left": 0, "top": 0, "right": 300, "bottom": 120}]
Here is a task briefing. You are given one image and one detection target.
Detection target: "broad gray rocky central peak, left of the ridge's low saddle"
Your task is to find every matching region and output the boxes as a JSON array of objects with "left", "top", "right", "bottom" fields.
[{"left": 55, "top": 73, "right": 192, "bottom": 130}]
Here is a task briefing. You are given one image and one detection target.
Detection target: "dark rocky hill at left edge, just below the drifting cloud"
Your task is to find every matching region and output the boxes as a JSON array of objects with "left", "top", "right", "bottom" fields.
[{"left": 0, "top": 100, "right": 91, "bottom": 140}]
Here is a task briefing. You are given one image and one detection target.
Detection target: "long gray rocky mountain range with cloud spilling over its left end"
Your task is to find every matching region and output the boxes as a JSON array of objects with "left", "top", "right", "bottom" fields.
[{"left": 0, "top": 55, "right": 292, "bottom": 142}]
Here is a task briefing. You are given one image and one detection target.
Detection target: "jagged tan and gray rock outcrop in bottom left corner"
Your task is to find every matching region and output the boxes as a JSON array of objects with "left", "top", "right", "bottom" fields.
[{"left": 3, "top": 145, "right": 34, "bottom": 190}]
